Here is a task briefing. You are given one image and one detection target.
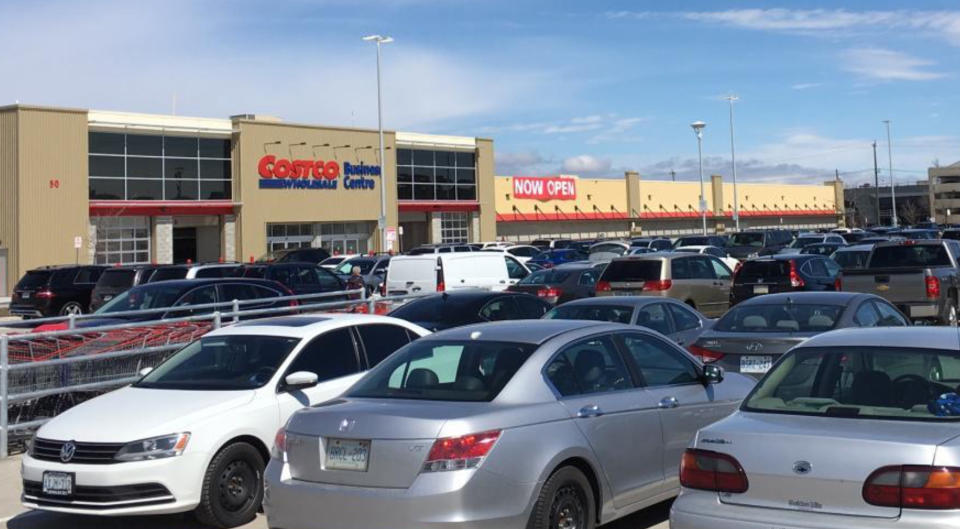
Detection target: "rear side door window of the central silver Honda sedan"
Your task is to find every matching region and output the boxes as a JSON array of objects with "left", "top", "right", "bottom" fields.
[{"left": 546, "top": 336, "right": 633, "bottom": 397}]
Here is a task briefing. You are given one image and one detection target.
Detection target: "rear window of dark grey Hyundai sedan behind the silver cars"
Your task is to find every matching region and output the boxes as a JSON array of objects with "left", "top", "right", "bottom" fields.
[{"left": 713, "top": 303, "right": 844, "bottom": 333}]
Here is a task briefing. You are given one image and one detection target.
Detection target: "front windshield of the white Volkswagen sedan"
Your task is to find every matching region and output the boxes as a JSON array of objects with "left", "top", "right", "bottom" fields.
[{"left": 134, "top": 335, "right": 300, "bottom": 391}]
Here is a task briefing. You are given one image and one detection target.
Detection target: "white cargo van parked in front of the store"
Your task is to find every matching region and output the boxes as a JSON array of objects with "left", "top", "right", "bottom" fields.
[{"left": 385, "top": 252, "right": 529, "bottom": 296}]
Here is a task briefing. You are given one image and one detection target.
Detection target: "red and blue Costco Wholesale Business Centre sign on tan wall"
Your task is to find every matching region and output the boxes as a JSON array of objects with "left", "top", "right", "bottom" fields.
[{"left": 257, "top": 154, "right": 380, "bottom": 189}]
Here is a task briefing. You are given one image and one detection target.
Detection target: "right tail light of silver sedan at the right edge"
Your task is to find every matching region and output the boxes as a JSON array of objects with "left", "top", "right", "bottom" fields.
[{"left": 863, "top": 465, "right": 960, "bottom": 509}]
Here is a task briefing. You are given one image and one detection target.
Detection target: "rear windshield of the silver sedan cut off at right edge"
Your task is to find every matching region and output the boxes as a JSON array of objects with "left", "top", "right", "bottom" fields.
[{"left": 743, "top": 346, "right": 960, "bottom": 421}]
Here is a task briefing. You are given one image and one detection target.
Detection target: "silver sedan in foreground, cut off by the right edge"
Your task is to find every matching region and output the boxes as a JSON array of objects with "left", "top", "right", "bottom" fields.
[{"left": 670, "top": 327, "right": 960, "bottom": 529}]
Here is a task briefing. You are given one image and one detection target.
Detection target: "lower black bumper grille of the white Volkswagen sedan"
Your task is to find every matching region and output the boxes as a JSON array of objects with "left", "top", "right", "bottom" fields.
[{"left": 23, "top": 480, "right": 174, "bottom": 509}]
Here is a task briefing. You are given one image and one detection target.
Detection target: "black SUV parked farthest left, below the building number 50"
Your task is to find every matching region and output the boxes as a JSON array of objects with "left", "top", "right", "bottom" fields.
[{"left": 10, "top": 265, "right": 106, "bottom": 319}]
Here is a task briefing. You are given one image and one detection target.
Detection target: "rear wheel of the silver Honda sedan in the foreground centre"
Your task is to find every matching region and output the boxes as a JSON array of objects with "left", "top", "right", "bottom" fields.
[{"left": 527, "top": 467, "right": 597, "bottom": 529}]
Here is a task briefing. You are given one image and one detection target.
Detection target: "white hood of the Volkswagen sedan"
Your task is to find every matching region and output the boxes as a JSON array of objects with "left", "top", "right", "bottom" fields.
[{"left": 37, "top": 386, "right": 255, "bottom": 443}]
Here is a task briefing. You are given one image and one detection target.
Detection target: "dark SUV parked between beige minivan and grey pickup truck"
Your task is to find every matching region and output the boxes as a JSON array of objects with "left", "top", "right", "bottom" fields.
[{"left": 730, "top": 254, "right": 840, "bottom": 306}]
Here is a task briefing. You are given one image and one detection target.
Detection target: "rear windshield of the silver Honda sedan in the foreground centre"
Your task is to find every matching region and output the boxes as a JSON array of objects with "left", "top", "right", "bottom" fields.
[{"left": 348, "top": 340, "right": 536, "bottom": 402}]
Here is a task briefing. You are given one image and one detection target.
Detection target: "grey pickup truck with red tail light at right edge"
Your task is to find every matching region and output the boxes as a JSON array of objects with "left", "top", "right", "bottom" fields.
[{"left": 839, "top": 240, "right": 960, "bottom": 326}]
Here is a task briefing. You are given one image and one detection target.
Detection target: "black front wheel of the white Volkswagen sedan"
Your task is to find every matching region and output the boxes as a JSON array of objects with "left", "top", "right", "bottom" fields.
[{"left": 194, "top": 443, "right": 264, "bottom": 529}]
